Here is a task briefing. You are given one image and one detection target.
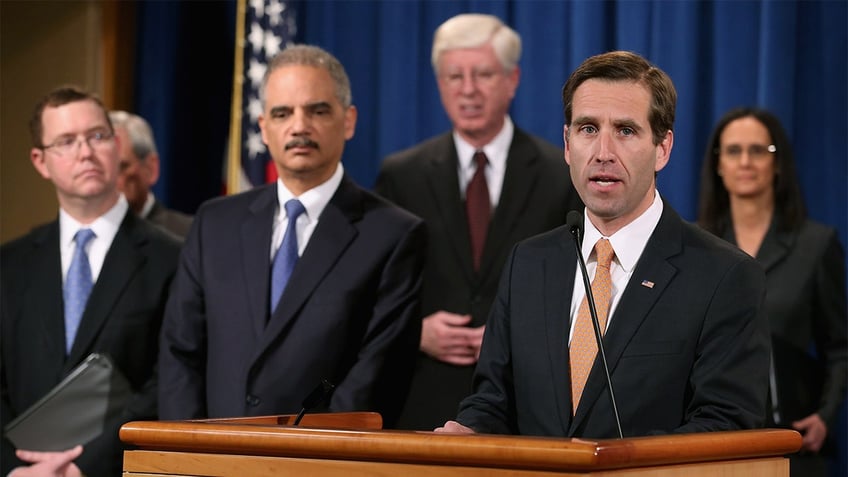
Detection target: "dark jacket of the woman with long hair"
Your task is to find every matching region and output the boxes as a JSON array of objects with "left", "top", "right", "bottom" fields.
[{"left": 724, "top": 220, "right": 848, "bottom": 435}]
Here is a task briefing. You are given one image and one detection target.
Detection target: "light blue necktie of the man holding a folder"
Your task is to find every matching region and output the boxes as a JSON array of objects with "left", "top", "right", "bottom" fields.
[{"left": 64, "top": 229, "right": 94, "bottom": 353}]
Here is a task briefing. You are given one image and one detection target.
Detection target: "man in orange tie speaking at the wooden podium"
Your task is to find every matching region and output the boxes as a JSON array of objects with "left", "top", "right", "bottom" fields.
[{"left": 437, "top": 52, "right": 770, "bottom": 438}]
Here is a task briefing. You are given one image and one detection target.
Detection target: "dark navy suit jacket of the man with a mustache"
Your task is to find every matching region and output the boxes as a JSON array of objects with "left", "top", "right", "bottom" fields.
[{"left": 159, "top": 173, "right": 425, "bottom": 422}]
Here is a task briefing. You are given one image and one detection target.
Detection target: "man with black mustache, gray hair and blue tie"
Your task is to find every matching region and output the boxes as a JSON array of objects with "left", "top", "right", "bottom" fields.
[{"left": 159, "top": 45, "right": 426, "bottom": 426}]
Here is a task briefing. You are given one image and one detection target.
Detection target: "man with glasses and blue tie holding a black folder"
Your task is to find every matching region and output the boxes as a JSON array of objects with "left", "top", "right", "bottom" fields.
[{"left": 0, "top": 87, "right": 180, "bottom": 477}]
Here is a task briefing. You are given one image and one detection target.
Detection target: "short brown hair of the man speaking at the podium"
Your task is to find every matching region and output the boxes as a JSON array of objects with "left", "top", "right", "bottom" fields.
[{"left": 562, "top": 51, "right": 677, "bottom": 145}]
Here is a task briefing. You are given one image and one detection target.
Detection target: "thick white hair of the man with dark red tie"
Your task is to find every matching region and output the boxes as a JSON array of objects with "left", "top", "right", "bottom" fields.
[{"left": 431, "top": 13, "right": 521, "bottom": 73}]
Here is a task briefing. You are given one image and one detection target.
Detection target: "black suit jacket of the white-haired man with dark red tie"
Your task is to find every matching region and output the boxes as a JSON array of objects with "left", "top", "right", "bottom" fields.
[{"left": 376, "top": 128, "right": 583, "bottom": 430}]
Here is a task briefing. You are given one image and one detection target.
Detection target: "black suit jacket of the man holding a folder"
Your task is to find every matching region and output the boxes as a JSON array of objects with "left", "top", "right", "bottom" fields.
[{"left": 0, "top": 211, "right": 180, "bottom": 476}]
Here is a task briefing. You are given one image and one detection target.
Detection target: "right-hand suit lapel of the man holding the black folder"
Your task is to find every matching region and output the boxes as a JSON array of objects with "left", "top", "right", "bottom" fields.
[{"left": 66, "top": 211, "right": 147, "bottom": 364}]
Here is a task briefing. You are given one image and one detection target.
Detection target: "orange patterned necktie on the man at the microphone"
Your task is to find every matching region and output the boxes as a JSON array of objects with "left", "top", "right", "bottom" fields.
[{"left": 569, "top": 239, "right": 615, "bottom": 413}]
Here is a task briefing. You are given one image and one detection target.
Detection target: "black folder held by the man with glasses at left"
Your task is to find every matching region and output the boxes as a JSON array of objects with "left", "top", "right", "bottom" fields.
[{"left": 3, "top": 353, "right": 131, "bottom": 451}]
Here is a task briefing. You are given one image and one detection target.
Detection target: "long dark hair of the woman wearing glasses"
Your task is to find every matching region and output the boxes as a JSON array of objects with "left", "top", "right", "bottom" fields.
[{"left": 698, "top": 107, "right": 807, "bottom": 236}]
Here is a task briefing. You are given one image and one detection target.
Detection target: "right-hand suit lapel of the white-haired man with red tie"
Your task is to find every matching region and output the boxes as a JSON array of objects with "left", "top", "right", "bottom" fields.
[{"left": 480, "top": 128, "right": 538, "bottom": 276}]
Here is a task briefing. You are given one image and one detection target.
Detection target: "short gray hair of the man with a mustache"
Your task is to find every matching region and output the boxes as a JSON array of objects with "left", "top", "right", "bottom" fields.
[{"left": 259, "top": 45, "right": 353, "bottom": 108}]
